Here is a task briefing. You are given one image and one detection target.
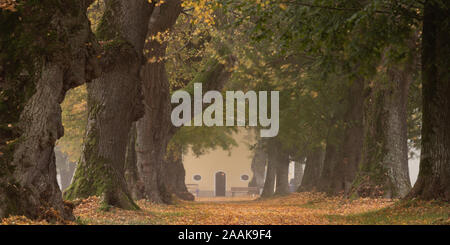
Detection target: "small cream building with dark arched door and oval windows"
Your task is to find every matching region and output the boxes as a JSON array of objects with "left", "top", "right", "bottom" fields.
[{"left": 183, "top": 130, "right": 254, "bottom": 197}]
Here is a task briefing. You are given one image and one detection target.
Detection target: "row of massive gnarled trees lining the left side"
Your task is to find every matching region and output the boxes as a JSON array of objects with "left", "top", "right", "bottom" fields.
[{"left": 0, "top": 0, "right": 233, "bottom": 219}]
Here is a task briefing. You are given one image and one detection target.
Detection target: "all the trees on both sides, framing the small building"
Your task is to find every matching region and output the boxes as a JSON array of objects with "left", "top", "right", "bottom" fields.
[{"left": 0, "top": 0, "right": 450, "bottom": 222}]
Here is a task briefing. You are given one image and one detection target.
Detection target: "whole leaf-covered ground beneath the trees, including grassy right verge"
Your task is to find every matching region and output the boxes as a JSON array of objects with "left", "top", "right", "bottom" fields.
[{"left": 3, "top": 193, "right": 450, "bottom": 225}]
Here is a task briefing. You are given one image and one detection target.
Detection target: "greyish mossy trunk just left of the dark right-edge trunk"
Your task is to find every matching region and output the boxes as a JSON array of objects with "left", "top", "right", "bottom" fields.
[{"left": 354, "top": 61, "right": 412, "bottom": 198}]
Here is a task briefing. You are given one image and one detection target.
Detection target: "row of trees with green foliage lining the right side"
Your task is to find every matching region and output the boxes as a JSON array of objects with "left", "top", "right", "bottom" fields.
[{"left": 229, "top": 0, "right": 450, "bottom": 201}]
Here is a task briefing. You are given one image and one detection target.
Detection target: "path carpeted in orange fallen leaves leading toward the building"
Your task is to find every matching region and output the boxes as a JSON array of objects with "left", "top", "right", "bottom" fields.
[{"left": 75, "top": 193, "right": 393, "bottom": 225}]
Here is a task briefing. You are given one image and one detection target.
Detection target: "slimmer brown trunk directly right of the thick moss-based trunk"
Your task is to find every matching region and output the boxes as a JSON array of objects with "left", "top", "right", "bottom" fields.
[{"left": 136, "top": 0, "right": 181, "bottom": 203}]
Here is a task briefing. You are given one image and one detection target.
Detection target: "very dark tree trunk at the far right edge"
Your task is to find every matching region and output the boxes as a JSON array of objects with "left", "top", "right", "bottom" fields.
[{"left": 408, "top": 1, "right": 450, "bottom": 202}]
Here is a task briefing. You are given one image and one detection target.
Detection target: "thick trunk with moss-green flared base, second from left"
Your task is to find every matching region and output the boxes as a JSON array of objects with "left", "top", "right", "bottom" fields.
[{"left": 65, "top": 0, "right": 152, "bottom": 209}]
